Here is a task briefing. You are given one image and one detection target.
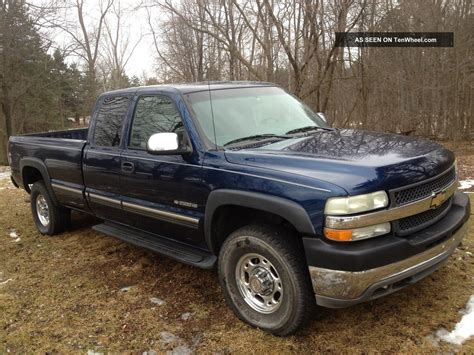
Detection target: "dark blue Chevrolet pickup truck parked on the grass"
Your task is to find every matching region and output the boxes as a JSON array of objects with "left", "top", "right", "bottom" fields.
[{"left": 9, "top": 82, "right": 470, "bottom": 336}]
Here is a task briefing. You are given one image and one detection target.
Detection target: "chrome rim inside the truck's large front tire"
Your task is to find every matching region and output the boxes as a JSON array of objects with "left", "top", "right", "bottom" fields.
[{"left": 235, "top": 254, "right": 283, "bottom": 314}]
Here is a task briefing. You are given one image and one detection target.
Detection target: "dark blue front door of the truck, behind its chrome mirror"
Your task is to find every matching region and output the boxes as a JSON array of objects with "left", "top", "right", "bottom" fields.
[{"left": 121, "top": 94, "right": 203, "bottom": 246}]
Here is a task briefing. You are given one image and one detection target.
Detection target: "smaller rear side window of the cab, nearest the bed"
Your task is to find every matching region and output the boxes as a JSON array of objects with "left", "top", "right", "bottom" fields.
[{"left": 94, "top": 96, "right": 130, "bottom": 147}]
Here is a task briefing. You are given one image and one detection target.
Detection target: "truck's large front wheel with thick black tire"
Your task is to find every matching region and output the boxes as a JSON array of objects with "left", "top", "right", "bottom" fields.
[{"left": 218, "top": 225, "right": 316, "bottom": 336}]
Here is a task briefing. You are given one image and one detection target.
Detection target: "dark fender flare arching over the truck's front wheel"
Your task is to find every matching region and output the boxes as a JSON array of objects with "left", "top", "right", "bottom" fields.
[{"left": 204, "top": 189, "right": 315, "bottom": 251}]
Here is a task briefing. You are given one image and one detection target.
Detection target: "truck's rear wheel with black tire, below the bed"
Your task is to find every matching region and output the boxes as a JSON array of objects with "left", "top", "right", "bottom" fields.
[{"left": 30, "top": 181, "right": 71, "bottom": 235}]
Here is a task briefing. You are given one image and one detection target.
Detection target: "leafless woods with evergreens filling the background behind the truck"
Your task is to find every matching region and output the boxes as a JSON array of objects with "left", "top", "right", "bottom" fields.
[{"left": 0, "top": 0, "right": 474, "bottom": 163}]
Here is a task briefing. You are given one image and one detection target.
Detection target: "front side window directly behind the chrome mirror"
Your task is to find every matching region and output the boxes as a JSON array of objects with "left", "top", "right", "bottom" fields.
[{"left": 129, "top": 95, "right": 184, "bottom": 149}]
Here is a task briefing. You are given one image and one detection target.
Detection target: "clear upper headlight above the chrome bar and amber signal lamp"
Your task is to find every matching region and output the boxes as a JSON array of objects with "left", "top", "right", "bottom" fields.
[{"left": 324, "top": 191, "right": 388, "bottom": 216}]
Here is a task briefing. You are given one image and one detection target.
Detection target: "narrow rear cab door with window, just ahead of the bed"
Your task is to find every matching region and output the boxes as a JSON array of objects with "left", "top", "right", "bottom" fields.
[{"left": 83, "top": 95, "right": 131, "bottom": 221}]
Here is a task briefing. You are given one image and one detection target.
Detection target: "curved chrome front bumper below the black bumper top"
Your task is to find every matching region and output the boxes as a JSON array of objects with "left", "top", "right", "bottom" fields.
[{"left": 309, "top": 223, "right": 468, "bottom": 308}]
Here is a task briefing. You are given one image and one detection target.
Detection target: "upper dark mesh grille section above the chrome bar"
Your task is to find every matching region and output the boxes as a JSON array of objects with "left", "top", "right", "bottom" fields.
[{"left": 393, "top": 167, "right": 456, "bottom": 206}]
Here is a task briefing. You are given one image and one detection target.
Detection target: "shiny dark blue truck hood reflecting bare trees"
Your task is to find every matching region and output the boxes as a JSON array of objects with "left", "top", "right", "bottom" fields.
[{"left": 225, "top": 129, "right": 454, "bottom": 195}]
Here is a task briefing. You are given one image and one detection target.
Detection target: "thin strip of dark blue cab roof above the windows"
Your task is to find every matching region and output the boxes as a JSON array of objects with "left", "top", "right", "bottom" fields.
[{"left": 101, "top": 81, "right": 275, "bottom": 96}]
